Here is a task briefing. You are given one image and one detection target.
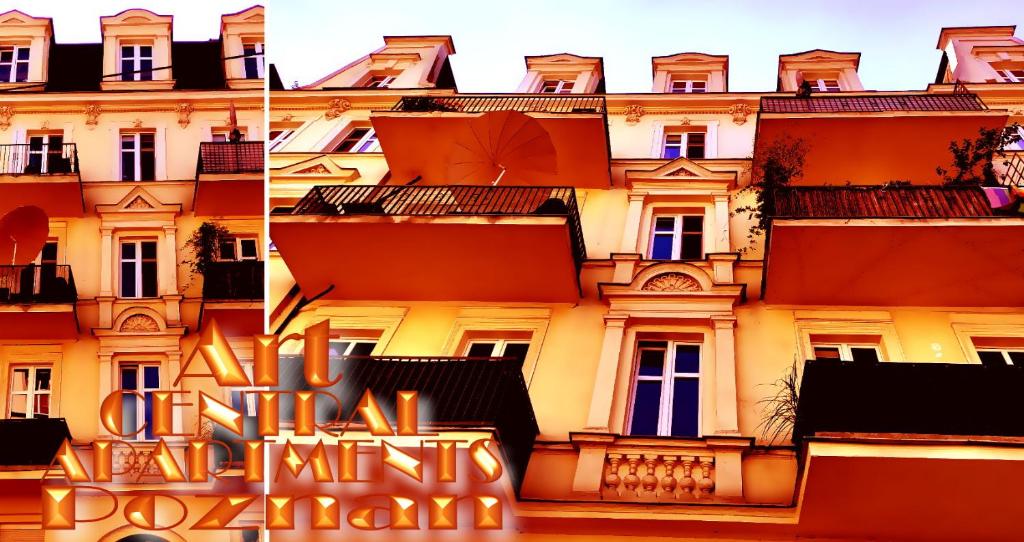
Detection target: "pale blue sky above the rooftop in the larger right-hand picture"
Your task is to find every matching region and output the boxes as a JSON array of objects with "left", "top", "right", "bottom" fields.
[{"left": 267, "top": 0, "right": 1024, "bottom": 92}]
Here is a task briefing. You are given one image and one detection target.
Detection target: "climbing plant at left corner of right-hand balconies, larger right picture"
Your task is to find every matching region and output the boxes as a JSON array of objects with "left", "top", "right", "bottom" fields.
[{"left": 734, "top": 135, "right": 807, "bottom": 244}]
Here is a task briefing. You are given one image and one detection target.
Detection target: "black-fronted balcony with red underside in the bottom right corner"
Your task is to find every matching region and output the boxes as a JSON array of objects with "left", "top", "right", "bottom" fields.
[{"left": 795, "top": 362, "right": 1024, "bottom": 540}]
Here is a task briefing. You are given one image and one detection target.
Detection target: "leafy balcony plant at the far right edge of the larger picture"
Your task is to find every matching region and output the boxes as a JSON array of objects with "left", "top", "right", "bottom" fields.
[{"left": 935, "top": 124, "right": 1021, "bottom": 186}]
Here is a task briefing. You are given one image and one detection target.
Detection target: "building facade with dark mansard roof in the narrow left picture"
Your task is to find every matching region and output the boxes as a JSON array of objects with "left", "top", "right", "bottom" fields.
[{"left": 0, "top": 6, "right": 265, "bottom": 541}]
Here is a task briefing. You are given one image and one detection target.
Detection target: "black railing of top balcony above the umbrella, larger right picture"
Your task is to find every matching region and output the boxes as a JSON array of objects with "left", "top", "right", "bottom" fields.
[{"left": 391, "top": 94, "right": 606, "bottom": 113}]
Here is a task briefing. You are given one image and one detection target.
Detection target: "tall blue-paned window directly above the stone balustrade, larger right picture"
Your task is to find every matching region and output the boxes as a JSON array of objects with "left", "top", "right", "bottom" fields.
[{"left": 629, "top": 341, "right": 700, "bottom": 436}]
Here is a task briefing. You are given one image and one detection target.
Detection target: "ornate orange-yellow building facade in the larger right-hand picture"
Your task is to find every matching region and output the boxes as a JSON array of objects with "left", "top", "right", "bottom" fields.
[{"left": 267, "top": 27, "right": 1024, "bottom": 540}]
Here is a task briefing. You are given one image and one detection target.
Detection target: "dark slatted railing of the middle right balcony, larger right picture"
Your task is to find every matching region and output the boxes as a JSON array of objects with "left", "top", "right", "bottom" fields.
[{"left": 774, "top": 185, "right": 995, "bottom": 218}]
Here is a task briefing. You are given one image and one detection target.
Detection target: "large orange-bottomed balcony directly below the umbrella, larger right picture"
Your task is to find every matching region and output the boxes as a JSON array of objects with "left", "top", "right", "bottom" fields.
[{"left": 270, "top": 185, "right": 587, "bottom": 302}]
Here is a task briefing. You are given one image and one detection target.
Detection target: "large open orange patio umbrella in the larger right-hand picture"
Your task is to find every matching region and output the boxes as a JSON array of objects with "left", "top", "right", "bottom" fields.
[{"left": 449, "top": 111, "right": 558, "bottom": 184}]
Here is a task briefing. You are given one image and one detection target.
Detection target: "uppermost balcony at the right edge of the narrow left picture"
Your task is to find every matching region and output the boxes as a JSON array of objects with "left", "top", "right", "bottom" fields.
[{"left": 195, "top": 141, "right": 263, "bottom": 216}]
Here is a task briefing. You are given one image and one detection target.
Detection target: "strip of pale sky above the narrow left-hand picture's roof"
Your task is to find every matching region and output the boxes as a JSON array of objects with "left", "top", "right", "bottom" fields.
[{"left": 0, "top": 0, "right": 264, "bottom": 43}]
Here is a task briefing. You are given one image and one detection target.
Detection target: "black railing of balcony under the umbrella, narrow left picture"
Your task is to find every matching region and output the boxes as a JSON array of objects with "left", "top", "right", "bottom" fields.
[{"left": 0, "top": 263, "right": 78, "bottom": 304}]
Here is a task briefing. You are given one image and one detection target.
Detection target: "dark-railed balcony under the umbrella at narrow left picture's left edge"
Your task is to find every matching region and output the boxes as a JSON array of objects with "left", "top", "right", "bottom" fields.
[{"left": 0, "top": 264, "right": 78, "bottom": 340}]
